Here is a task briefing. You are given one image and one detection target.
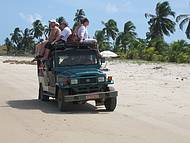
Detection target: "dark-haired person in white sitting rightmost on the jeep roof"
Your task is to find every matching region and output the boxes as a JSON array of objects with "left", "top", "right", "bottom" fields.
[{"left": 77, "top": 18, "right": 97, "bottom": 43}]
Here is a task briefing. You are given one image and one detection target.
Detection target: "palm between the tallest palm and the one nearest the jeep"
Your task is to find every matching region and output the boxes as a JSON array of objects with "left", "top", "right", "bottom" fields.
[{"left": 116, "top": 21, "right": 137, "bottom": 52}]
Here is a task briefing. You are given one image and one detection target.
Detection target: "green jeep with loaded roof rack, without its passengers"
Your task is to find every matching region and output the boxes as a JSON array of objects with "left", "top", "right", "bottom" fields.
[{"left": 38, "top": 44, "right": 118, "bottom": 111}]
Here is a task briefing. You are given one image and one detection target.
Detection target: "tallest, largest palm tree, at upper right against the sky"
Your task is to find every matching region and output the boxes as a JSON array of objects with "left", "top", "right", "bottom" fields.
[{"left": 145, "top": 1, "right": 175, "bottom": 39}]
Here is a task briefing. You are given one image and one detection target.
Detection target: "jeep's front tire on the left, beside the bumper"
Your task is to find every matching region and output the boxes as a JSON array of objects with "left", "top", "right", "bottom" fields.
[{"left": 57, "top": 89, "right": 68, "bottom": 112}]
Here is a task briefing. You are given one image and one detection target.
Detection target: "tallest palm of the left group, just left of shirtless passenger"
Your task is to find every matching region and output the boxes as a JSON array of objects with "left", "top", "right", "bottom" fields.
[{"left": 32, "top": 20, "right": 44, "bottom": 40}]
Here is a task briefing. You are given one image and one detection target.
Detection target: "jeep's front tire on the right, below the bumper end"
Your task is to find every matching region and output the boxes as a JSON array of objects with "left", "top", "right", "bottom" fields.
[{"left": 104, "top": 97, "right": 117, "bottom": 112}]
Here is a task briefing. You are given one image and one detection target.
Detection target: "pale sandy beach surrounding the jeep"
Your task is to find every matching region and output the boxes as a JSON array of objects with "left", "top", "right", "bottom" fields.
[{"left": 0, "top": 57, "right": 190, "bottom": 143}]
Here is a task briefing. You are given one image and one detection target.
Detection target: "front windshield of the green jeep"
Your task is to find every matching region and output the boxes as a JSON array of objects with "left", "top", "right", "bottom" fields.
[{"left": 56, "top": 50, "right": 99, "bottom": 67}]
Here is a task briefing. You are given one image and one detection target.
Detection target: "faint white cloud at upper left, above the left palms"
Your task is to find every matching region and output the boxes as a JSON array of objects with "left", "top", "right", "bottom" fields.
[{"left": 19, "top": 12, "right": 42, "bottom": 23}]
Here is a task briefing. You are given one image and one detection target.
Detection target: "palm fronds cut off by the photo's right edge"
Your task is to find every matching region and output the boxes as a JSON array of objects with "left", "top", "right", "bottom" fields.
[{"left": 176, "top": 14, "right": 190, "bottom": 39}]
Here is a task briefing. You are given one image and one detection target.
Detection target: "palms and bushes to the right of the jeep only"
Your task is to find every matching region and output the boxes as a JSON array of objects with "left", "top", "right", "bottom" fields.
[{"left": 95, "top": 1, "right": 190, "bottom": 63}]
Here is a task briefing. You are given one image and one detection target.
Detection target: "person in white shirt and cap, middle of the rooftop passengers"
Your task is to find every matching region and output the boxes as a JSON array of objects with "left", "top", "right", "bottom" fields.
[{"left": 57, "top": 21, "right": 72, "bottom": 43}]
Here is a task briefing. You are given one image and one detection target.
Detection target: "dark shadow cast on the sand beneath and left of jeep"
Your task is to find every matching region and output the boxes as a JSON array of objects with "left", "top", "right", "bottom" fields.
[{"left": 7, "top": 99, "right": 106, "bottom": 114}]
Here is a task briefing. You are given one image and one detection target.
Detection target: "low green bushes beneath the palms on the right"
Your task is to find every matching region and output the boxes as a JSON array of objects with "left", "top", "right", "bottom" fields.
[{"left": 116, "top": 40, "right": 190, "bottom": 63}]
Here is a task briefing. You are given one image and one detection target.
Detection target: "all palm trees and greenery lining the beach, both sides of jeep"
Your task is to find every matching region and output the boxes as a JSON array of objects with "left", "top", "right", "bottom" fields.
[{"left": 3, "top": 1, "right": 190, "bottom": 63}]
